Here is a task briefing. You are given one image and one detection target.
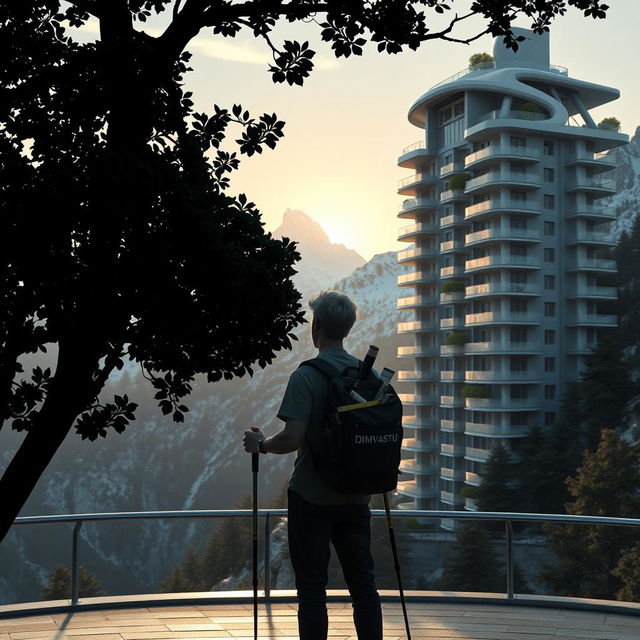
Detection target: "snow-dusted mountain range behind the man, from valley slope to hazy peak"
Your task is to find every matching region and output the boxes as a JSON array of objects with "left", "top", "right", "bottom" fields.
[{"left": 0, "top": 212, "right": 400, "bottom": 603}]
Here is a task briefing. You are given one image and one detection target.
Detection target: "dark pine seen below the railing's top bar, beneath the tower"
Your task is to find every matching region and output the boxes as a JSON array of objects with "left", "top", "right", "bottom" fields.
[{"left": 438, "top": 522, "right": 506, "bottom": 592}]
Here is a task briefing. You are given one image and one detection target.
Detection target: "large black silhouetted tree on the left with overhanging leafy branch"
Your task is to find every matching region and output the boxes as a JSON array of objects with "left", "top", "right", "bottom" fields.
[{"left": 0, "top": 0, "right": 606, "bottom": 540}]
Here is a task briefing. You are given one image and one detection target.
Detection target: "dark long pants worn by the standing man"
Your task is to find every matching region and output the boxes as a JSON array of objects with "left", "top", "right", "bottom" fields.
[{"left": 288, "top": 491, "right": 382, "bottom": 640}]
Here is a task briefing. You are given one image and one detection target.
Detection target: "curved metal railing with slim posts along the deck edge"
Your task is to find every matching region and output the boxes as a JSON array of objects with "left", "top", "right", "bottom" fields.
[{"left": 7, "top": 510, "right": 640, "bottom": 607}]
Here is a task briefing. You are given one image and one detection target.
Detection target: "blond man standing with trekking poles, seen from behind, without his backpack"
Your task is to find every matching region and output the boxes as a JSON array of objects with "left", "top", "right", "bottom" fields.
[{"left": 244, "top": 291, "right": 382, "bottom": 640}]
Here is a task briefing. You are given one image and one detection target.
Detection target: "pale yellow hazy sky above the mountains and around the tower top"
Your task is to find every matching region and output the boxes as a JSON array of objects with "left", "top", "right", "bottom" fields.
[{"left": 74, "top": 0, "right": 640, "bottom": 258}]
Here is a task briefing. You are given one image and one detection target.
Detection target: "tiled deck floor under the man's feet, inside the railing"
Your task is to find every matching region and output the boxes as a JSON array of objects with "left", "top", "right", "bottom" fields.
[{"left": 0, "top": 603, "right": 640, "bottom": 640}]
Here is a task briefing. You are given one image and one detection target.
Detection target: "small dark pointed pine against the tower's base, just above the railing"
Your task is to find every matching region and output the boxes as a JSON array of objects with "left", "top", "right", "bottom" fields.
[{"left": 473, "top": 445, "right": 518, "bottom": 511}]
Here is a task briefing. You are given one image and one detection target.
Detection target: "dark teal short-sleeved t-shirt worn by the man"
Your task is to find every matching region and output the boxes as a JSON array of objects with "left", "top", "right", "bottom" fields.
[{"left": 278, "top": 349, "right": 371, "bottom": 505}]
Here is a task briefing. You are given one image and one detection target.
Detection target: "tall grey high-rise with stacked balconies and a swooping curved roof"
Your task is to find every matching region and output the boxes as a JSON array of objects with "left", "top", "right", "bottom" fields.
[{"left": 398, "top": 29, "right": 627, "bottom": 510}]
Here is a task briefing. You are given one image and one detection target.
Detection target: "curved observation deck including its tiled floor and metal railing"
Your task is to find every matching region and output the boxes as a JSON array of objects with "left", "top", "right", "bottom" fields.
[{"left": 0, "top": 510, "right": 640, "bottom": 640}]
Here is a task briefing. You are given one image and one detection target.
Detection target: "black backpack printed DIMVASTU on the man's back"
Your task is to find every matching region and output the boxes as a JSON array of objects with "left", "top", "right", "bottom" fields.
[{"left": 300, "top": 358, "right": 402, "bottom": 494}]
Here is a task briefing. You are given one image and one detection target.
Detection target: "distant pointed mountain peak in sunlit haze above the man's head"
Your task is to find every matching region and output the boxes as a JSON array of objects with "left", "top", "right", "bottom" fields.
[{"left": 273, "top": 209, "right": 365, "bottom": 300}]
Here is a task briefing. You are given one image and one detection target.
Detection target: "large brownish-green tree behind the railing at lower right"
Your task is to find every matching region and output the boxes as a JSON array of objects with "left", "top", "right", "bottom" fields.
[{"left": 543, "top": 429, "right": 640, "bottom": 599}]
